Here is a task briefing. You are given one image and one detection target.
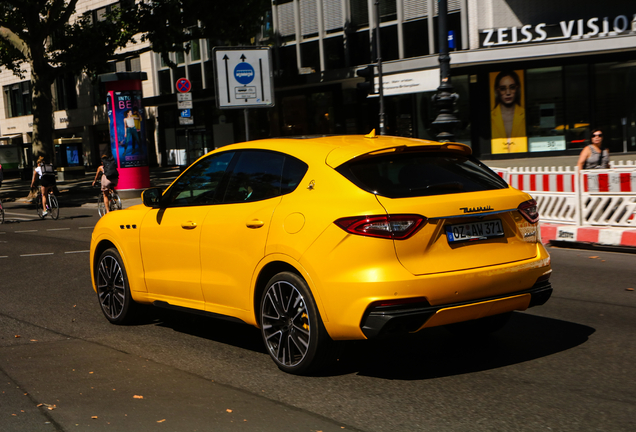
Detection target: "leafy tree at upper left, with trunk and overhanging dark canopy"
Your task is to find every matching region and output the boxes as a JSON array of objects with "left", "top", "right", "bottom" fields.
[{"left": 0, "top": 0, "right": 269, "bottom": 162}]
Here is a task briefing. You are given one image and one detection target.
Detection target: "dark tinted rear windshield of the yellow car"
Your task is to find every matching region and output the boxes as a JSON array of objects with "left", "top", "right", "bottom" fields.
[{"left": 336, "top": 151, "right": 508, "bottom": 198}]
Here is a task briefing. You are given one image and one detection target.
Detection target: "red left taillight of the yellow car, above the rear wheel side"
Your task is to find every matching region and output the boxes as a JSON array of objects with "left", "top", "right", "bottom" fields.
[{"left": 334, "top": 215, "right": 427, "bottom": 240}]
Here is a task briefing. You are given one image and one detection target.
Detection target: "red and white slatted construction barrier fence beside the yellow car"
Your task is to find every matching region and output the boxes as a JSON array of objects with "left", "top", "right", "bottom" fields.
[{"left": 491, "top": 161, "right": 636, "bottom": 228}]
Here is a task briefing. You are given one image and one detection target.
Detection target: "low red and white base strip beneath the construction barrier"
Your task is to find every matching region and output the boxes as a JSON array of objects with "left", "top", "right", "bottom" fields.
[{"left": 541, "top": 223, "right": 636, "bottom": 248}]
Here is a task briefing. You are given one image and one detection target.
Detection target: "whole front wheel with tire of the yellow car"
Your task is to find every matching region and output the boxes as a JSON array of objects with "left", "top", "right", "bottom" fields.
[{"left": 94, "top": 248, "right": 137, "bottom": 324}]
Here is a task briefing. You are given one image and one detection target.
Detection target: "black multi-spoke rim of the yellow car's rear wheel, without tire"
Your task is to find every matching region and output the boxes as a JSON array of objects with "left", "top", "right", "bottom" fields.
[{"left": 261, "top": 281, "right": 311, "bottom": 367}]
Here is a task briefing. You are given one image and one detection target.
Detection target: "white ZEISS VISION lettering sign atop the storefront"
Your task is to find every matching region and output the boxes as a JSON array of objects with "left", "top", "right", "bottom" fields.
[{"left": 479, "top": 14, "right": 636, "bottom": 48}]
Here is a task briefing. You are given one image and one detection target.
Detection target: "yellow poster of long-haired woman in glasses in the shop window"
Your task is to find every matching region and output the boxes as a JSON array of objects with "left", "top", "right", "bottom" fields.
[{"left": 490, "top": 70, "right": 528, "bottom": 154}]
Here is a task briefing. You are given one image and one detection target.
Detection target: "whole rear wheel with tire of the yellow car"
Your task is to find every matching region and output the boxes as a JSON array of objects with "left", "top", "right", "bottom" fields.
[{"left": 259, "top": 272, "right": 333, "bottom": 375}]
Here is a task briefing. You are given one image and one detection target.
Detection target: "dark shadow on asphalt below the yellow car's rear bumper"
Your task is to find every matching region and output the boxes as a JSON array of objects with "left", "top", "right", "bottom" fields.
[{"left": 324, "top": 312, "right": 595, "bottom": 380}]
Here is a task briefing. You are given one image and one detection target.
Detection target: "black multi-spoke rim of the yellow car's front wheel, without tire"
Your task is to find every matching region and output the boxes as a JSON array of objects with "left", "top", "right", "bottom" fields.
[{"left": 97, "top": 255, "right": 126, "bottom": 320}]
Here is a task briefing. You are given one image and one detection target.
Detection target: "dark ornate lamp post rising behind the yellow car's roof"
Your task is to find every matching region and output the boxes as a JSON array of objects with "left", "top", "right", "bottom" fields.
[{"left": 433, "top": 0, "right": 459, "bottom": 141}]
